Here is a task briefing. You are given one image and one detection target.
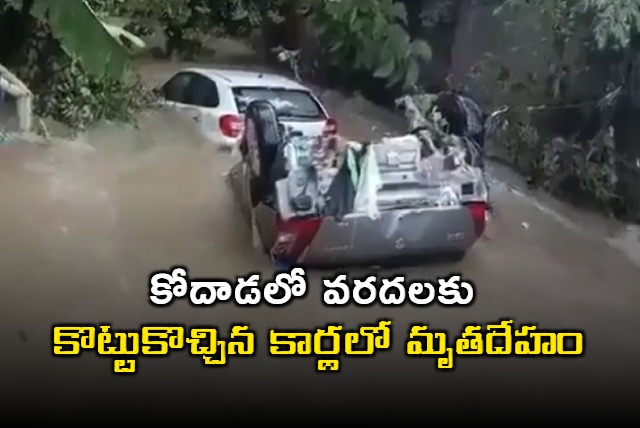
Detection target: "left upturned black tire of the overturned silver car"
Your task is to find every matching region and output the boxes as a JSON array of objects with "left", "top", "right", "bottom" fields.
[{"left": 242, "top": 100, "right": 281, "bottom": 184}]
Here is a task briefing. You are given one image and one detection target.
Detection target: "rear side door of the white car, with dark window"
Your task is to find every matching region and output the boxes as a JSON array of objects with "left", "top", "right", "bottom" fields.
[{"left": 183, "top": 74, "right": 220, "bottom": 142}]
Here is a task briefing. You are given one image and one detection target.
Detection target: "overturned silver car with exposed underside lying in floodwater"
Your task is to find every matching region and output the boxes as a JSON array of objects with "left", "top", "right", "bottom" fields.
[{"left": 228, "top": 94, "right": 488, "bottom": 266}]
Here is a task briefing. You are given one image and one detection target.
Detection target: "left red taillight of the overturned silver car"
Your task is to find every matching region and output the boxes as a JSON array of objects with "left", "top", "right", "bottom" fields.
[{"left": 272, "top": 218, "right": 322, "bottom": 262}]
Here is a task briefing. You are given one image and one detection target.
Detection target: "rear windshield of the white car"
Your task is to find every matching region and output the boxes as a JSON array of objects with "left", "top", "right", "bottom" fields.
[{"left": 233, "top": 87, "right": 326, "bottom": 120}]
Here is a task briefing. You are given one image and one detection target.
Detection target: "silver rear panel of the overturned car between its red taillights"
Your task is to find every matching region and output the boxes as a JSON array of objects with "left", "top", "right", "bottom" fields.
[{"left": 299, "top": 206, "right": 478, "bottom": 266}]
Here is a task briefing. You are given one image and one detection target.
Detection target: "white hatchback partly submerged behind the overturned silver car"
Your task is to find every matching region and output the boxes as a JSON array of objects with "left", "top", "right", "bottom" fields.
[{"left": 161, "top": 68, "right": 337, "bottom": 148}]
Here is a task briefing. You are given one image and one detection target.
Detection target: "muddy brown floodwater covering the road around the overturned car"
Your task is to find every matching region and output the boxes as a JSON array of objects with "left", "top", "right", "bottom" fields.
[{"left": 0, "top": 77, "right": 640, "bottom": 418}]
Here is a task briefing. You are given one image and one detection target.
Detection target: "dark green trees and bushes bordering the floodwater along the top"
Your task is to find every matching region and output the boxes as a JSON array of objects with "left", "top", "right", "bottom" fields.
[{"left": 0, "top": 0, "right": 640, "bottom": 221}]
